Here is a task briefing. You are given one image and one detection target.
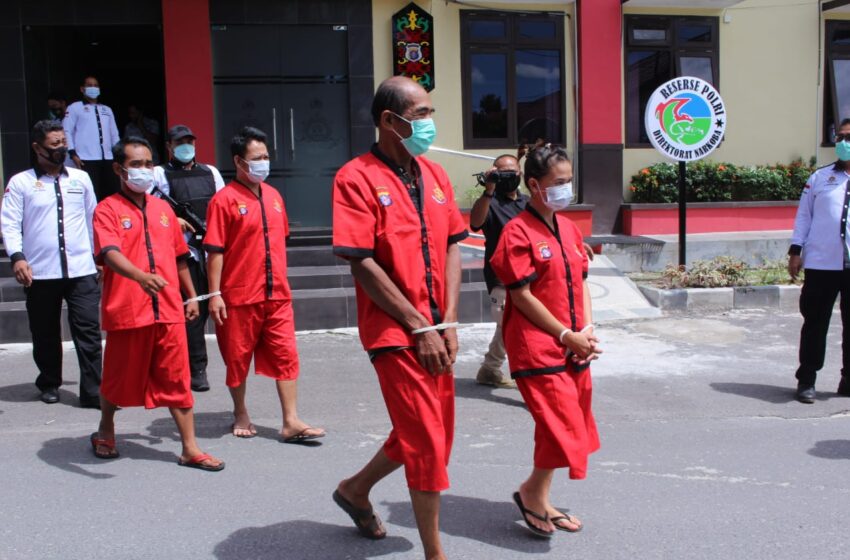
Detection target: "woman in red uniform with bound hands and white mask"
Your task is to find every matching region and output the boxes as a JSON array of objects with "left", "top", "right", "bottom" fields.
[{"left": 490, "top": 144, "right": 601, "bottom": 537}]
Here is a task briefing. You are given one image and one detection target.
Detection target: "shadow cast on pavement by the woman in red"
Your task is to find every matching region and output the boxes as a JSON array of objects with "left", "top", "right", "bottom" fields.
[{"left": 382, "top": 492, "right": 551, "bottom": 558}]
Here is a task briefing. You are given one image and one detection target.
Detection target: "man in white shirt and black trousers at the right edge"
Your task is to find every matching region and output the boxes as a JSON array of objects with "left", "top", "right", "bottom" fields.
[{"left": 788, "top": 119, "right": 850, "bottom": 404}]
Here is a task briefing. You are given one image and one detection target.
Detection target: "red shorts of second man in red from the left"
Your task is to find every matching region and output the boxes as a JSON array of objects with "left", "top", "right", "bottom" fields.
[{"left": 215, "top": 300, "right": 298, "bottom": 387}]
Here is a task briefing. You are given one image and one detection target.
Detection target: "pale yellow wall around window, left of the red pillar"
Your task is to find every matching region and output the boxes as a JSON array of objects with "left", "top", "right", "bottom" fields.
[{"left": 372, "top": 0, "right": 575, "bottom": 207}]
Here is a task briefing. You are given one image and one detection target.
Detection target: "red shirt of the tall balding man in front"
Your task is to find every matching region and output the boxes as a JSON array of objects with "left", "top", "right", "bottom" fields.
[{"left": 333, "top": 146, "right": 469, "bottom": 350}]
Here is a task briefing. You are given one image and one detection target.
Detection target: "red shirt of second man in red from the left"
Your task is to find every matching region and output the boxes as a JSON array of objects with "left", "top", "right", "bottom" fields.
[{"left": 204, "top": 181, "right": 292, "bottom": 305}]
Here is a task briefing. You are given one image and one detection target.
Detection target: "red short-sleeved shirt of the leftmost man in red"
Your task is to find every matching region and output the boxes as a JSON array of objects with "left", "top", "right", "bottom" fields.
[{"left": 93, "top": 193, "right": 189, "bottom": 331}]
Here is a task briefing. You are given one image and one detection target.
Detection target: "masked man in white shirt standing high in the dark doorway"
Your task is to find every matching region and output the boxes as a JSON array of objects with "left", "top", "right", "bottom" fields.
[{"left": 62, "top": 76, "right": 121, "bottom": 201}]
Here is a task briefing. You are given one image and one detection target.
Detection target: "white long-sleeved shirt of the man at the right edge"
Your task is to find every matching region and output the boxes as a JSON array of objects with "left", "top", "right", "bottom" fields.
[{"left": 791, "top": 165, "right": 850, "bottom": 270}]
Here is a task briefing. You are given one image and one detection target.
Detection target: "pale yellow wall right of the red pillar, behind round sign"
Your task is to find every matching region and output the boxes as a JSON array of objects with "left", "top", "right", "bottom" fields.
[{"left": 623, "top": 0, "right": 830, "bottom": 199}]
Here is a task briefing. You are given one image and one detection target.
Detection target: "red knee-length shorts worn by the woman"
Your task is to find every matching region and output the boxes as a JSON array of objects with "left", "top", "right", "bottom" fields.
[{"left": 516, "top": 368, "right": 599, "bottom": 479}]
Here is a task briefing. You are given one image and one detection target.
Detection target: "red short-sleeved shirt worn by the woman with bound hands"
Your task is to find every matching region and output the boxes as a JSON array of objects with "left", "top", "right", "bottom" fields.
[{"left": 490, "top": 206, "right": 588, "bottom": 378}]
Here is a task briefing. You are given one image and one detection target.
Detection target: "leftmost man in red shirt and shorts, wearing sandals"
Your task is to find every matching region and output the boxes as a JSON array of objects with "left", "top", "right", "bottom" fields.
[{"left": 91, "top": 137, "right": 224, "bottom": 471}]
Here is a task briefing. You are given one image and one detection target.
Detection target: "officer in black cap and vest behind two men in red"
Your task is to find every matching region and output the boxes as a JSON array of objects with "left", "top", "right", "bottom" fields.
[{"left": 153, "top": 124, "right": 224, "bottom": 392}]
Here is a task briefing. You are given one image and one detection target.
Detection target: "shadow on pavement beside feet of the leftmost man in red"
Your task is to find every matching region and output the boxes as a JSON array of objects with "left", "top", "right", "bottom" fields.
[{"left": 37, "top": 430, "right": 174, "bottom": 478}]
